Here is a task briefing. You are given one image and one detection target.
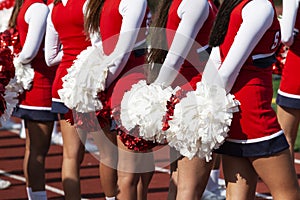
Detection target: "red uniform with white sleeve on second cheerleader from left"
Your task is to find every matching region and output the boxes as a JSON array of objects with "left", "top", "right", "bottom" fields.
[{"left": 45, "top": 0, "right": 91, "bottom": 113}]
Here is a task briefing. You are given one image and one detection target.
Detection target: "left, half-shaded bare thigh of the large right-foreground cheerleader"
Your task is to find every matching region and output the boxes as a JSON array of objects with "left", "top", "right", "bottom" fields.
[{"left": 222, "top": 155, "right": 258, "bottom": 200}]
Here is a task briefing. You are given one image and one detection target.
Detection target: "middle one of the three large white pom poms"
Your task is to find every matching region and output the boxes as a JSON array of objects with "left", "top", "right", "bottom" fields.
[{"left": 120, "top": 80, "right": 174, "bottom": 142}]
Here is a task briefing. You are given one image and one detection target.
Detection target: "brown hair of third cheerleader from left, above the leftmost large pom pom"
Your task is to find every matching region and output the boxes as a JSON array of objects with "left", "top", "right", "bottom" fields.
[{"left": 84, "top": 0, "right": 105, "bottom": 36}]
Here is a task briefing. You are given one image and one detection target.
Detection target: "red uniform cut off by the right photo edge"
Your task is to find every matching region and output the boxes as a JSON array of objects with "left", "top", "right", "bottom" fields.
[{"left": 276, "top": 8, "right": 300, "bottom": 109}]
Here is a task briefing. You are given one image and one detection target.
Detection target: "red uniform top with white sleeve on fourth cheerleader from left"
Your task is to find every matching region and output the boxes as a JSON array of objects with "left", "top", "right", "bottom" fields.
[{"left": 155, "top": 0, "right": 217, "bottom": 90}]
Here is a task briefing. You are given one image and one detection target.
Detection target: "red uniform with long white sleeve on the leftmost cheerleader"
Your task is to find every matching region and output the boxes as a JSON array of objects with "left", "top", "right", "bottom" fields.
[{"left": 13, "top": 0, "right": 56, "bottom": 120}]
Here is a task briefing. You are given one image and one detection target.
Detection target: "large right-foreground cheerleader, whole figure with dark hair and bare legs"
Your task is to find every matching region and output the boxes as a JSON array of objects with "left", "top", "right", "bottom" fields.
[{"left": 206, "top": 0, "right": 300, "bottom": 200}]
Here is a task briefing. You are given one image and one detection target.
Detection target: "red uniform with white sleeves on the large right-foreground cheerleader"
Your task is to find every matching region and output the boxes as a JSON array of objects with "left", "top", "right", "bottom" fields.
[{"left": 211, "top": 0, "right": 288, "bottom": 157}]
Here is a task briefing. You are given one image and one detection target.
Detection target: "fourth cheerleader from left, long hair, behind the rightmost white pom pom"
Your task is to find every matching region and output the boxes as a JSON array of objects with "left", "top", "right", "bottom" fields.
[{"left": 148, "top": 0, "right": 218, "bottom": 199}]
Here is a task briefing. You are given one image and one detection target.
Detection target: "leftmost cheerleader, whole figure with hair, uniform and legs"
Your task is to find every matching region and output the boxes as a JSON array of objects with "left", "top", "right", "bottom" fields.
[{"left": 9, "top": 0, "right": 57, "bottom": 199}]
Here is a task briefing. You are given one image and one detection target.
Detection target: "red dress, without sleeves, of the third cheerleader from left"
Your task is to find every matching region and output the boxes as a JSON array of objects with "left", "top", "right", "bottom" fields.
[{"left": 100, "top": 0, "right": 146, "bottom": 115}]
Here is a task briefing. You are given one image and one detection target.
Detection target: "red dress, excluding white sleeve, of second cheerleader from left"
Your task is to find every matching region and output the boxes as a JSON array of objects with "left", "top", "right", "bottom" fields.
[{"left": 51, "top": 0, "right": 91, "bottom": 113}]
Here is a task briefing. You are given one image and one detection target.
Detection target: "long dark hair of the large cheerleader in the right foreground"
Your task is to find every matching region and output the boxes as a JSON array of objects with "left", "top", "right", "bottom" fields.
[{"left": 209, "top": 0, "right": 243, "bottom": 47}]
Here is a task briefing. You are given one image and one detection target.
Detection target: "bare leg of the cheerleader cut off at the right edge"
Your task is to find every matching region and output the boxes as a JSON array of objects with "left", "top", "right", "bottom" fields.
[{"left": 277, "top": 106, "right": 300, "bottom": 160}]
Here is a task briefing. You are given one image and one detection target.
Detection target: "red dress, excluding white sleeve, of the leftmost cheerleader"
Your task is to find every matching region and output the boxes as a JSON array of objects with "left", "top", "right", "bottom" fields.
[{"left": 13, "top": 0, "right": 56, "bottom": 121}]
